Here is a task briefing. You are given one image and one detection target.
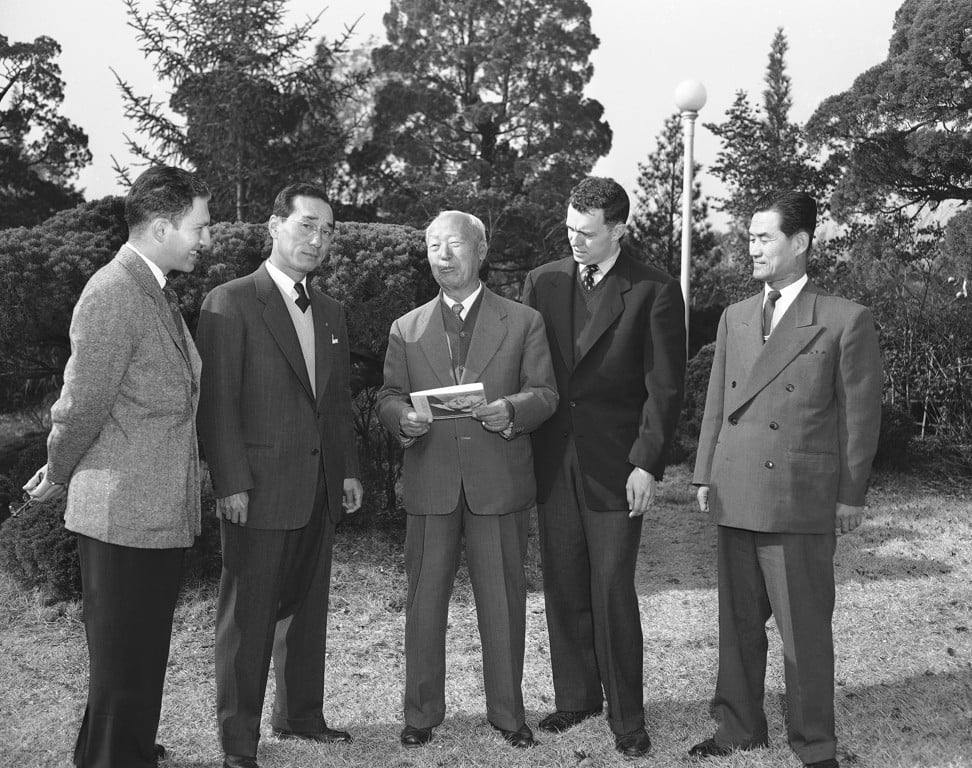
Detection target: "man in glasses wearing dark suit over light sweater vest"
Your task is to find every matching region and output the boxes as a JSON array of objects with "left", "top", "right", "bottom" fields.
[{"left": 197, "top": 184, "right": 362, "bottom": 768}]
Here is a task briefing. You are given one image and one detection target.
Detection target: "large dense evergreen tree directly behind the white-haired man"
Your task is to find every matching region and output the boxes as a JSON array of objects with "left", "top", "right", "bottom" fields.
[{"left": 352, "top": 0, "right": 611, "bottom": 293}]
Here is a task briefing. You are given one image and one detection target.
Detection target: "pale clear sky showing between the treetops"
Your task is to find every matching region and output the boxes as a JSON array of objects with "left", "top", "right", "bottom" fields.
[{"left": 0, "top": 0, "right": 903, "bottom": 222}]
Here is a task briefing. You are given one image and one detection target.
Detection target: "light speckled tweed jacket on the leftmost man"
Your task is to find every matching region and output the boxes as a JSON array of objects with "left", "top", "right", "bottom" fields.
[{"left": 47, "top": 246, "right": 200, "bottom": 549}]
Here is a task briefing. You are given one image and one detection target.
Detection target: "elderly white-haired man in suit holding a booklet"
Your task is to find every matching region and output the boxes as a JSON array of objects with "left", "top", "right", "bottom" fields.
[{"left": 379, "top": 211, "right": 557, "bottom": 747}]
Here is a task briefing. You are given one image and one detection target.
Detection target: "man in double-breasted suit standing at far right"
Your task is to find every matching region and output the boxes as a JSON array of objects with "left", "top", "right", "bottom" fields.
[{"left": 690, "top": 192, "right": 883, "bottom": 768}]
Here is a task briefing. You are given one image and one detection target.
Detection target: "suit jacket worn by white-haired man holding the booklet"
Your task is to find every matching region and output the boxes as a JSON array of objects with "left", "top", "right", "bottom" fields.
[{"left": 378, "top": 286, "right": 557, "bottom": 515}]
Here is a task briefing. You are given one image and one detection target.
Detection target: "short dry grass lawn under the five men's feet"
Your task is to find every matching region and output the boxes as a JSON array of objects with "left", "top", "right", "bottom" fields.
[{"left": 0, "top": 468, "right": 972, "bottom": 768}]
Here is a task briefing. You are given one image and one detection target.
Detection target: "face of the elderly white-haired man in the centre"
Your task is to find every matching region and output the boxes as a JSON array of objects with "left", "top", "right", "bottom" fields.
[{"left": 425, "top": 214, "right": 486, "bottom": 301}]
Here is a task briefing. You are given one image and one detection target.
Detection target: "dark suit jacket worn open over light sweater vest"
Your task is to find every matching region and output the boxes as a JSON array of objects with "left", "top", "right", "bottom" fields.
[{"left": 197, "top": 265, "right": 358, "bottom": 530}]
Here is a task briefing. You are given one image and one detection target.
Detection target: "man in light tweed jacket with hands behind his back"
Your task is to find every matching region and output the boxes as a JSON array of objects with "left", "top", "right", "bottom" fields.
[{"left": 25, "top": 166, "right": 209, "bottom": 768}]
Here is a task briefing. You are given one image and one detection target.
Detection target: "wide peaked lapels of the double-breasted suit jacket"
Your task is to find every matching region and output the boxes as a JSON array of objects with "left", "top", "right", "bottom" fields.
[{"left": 729, "top": 283, "right": 823, "bottom": 414}]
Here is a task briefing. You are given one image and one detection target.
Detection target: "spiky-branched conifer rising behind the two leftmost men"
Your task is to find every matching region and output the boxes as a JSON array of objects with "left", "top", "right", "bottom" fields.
[{"left": 116, "top": 0, "right": 360, "bottom": 221}]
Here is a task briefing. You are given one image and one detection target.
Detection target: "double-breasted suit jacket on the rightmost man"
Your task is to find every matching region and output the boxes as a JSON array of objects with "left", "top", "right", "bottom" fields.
[{"left": 693, "top": 283, "right": 883, "bottom": 533}]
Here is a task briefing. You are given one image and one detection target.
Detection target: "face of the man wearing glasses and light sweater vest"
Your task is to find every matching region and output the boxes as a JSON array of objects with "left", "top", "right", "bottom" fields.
[{"left": 268, "top": 195, "right": 334, "bottom": 283}]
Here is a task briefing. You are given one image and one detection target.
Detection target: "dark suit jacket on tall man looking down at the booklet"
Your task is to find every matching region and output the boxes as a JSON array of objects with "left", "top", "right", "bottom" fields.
[{"left": 523, "top": 246, "right": 685, "bottom": 510}]
